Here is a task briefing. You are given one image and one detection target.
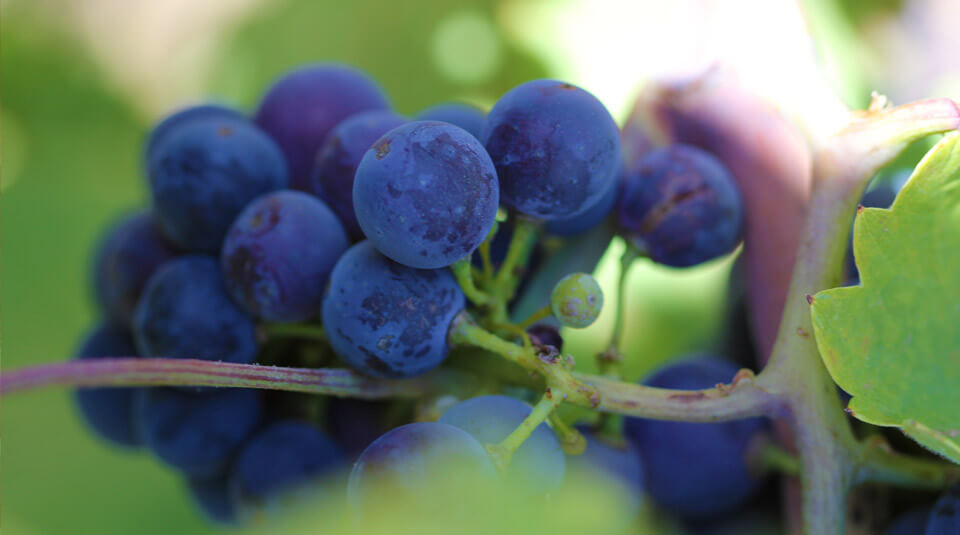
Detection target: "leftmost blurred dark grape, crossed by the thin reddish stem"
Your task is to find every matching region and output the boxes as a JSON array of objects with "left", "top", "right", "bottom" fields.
[{"left": 74, "top": 323, "right": 140, "bottom": 448}]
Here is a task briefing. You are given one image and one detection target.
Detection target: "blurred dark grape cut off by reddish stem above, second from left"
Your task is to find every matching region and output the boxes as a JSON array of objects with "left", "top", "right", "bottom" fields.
[{"left": 134, "top": 388, "right": 263, "bottom": 478}]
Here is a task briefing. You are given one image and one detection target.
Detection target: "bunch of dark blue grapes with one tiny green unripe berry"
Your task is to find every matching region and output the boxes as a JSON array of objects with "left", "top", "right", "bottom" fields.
[{"left": 69, "top": 64, "right": 766, "bottom": 523}]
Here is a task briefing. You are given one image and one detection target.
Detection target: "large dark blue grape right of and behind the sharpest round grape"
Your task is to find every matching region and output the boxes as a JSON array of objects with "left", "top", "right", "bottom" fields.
[{"left": 481, "top": 80, "right": 620, "bottom": 220}]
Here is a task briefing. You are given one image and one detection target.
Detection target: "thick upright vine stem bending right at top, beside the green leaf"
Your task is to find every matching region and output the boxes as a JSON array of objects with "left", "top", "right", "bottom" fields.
[{"left": 757, "top": 94, "right": 960, "bottom": 535}]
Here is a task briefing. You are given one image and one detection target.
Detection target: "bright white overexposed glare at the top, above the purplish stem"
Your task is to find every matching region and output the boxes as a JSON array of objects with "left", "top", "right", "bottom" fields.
[{"left": 499, "top": 0, "right": 845, "bottom": 140}]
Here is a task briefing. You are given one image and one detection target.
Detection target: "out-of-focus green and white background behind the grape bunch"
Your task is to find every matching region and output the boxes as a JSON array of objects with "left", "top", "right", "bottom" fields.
[{"left": 0, "top": 0, "right": 960, "bottom": 535}]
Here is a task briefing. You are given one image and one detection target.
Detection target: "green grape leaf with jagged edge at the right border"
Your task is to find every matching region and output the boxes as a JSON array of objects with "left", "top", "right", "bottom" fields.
[{"left": 812, "top": 133, "right": 960, "bottom": 463}]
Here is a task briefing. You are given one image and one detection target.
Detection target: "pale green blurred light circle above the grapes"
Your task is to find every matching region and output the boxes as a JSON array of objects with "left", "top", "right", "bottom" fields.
[{"left": 432, "top": 11, "right": 502, "bottom": 84}]
